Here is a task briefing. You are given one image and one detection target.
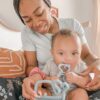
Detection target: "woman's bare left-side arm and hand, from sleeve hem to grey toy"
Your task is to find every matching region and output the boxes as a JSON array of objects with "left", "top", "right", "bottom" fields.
[{"left": 22, "top": 51, "right": 45, "bottom": 100}]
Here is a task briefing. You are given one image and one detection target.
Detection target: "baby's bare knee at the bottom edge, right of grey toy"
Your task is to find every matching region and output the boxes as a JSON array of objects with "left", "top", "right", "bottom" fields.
[{"left": 66, "top": 88, "right": 89, "bottom": 100}]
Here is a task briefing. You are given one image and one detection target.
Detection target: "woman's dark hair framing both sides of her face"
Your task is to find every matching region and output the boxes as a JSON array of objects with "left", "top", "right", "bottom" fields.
[{"left": 13, "top": 0, "right": 51, "bottom": 24}]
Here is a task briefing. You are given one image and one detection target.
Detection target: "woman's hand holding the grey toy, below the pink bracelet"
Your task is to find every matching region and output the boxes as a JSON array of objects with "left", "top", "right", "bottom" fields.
[{"left": 22, "top": 74, "right": 42, "bottom": 100}]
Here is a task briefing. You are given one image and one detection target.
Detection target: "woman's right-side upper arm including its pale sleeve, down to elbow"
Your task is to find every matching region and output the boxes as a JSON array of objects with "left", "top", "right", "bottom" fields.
[{"left": 73, "top": 19, "right": 100, "bottom": 66}]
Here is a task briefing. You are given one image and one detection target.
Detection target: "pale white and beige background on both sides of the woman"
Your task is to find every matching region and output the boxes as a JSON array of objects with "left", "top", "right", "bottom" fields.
[{"left": 0, "top": 0, "right": 95, "bottom": 51}]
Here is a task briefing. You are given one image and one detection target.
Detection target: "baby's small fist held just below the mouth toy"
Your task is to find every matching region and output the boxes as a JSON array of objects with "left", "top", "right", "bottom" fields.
[{"left": 65, "top": 72, "right": 77, "bottom": 84}]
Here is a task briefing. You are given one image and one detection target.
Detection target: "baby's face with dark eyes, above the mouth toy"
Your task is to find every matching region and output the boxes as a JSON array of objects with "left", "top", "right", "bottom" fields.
[{"left": 52, "top": 35, "right": 82, "bottom": 69}]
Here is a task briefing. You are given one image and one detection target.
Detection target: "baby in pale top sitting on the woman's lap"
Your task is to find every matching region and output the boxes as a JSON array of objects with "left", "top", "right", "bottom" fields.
[{"left": 34, "top": 29, "right": 90, "bottom": 100}]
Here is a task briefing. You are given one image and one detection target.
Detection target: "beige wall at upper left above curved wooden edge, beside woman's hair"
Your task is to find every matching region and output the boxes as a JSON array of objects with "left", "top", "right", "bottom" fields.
[{"left": 0, "top": 0, "right": 22, "bottom": 30}]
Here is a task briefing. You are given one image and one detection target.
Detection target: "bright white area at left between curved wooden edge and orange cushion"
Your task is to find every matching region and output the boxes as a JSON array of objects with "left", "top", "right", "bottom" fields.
[{"left": 0, "top": 26, "right": 22, "bottom": 50}]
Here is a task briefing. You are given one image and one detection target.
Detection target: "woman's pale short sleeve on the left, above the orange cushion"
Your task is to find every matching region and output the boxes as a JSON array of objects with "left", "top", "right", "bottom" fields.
[{"left": 21, "top": 27, "right": 36, "bottom": 51}]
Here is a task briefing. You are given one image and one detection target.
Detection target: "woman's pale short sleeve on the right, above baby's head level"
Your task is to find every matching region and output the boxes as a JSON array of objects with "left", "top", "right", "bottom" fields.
[{"left": 73, "top": 19, "right": 87, "bottom": 44}]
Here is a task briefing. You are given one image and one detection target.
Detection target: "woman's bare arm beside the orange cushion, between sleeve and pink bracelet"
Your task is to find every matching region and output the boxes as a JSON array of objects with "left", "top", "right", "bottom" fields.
[{"left": 24, "top": 51, "right": 38, "bottom": 76}]
